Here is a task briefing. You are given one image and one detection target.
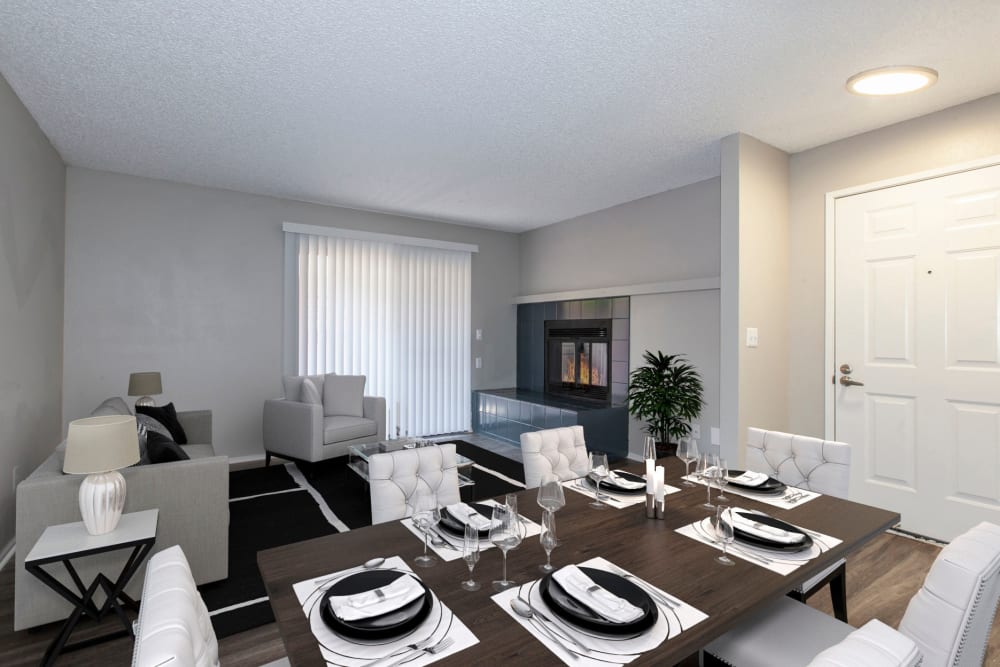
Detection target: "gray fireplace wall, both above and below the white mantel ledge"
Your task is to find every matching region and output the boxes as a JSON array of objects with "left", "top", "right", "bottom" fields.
[{"left": 521, "top": 178, "right": 721, "bottom": 460}]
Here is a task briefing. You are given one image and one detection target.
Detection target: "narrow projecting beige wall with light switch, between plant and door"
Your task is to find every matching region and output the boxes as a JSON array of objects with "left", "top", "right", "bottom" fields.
[{"left": 721, "top": 134, "right": 789, "bottom": 462}]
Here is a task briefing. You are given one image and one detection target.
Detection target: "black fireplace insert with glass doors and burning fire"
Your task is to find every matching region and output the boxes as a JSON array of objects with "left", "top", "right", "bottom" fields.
[{"left": 545, "top": 319, "right": 611, "bottom": 405}]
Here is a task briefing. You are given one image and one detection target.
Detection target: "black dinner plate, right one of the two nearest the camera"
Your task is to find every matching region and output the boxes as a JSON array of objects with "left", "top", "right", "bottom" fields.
[{"left": 538, "top": 567, "right": 659, "bottom": 635}]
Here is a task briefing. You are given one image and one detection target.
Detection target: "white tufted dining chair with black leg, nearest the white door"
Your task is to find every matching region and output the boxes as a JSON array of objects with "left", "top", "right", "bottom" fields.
[{"left": 747, "top": 427, "right": 851, "bottom": 623}]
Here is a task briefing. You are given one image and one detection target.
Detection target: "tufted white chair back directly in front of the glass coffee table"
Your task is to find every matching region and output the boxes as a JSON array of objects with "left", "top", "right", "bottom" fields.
[{"left": 368, "top": 443, "right": 461, "bottom": 524}]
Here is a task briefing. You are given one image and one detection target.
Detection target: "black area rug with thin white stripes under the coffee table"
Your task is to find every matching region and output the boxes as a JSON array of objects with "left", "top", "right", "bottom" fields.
[{"left": 198, "top": 440, "right": 524, "bottom": 639}]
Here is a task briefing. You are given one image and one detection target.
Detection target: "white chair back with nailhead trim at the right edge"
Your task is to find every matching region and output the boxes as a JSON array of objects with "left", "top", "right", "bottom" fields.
[{"left": 899, "top": 522, "right": 1000, "bottom": 667}]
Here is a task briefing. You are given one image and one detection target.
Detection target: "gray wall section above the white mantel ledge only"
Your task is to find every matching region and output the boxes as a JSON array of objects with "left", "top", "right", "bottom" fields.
[{"left": 521, "top": 178, "right": 719, "bottom": 295}]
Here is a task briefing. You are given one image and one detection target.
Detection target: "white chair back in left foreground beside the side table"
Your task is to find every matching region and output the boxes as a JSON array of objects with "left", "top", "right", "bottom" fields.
[{"left": 132, "top": 545, "right": 219, "bottom": 667}]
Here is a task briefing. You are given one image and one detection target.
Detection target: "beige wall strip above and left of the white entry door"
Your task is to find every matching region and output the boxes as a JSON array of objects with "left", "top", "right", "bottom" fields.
[{"left": 787, "top": 95, "right": 1000, "bottom": 436}]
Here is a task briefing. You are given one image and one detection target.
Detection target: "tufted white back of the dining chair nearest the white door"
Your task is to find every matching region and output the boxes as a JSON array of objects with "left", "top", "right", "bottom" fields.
[{"left": 747, "top": 427, "right": 851, "bottom": 498}]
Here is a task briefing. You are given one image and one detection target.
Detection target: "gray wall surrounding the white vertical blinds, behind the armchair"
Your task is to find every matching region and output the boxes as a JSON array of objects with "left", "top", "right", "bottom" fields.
[{"left": 63, "top": 168, "right": 518, "bottom": 456}]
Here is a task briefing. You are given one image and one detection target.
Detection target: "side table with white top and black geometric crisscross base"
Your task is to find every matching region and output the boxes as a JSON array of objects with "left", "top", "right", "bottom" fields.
[{"left": 24, "top": 510, "right": 159, "bottom": 666}]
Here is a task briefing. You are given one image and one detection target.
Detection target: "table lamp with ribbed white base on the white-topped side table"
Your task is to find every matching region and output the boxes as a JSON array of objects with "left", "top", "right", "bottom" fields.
[{"left": 63, "top": 415, "right": 139, "bottom": 535}]
